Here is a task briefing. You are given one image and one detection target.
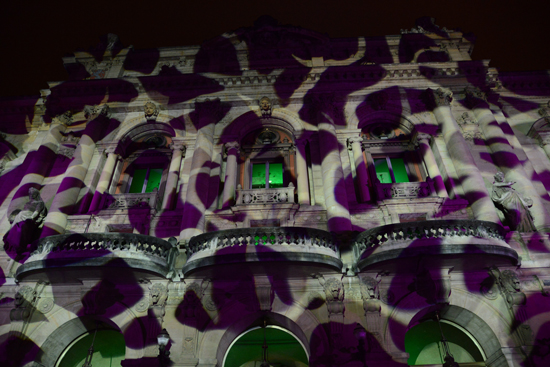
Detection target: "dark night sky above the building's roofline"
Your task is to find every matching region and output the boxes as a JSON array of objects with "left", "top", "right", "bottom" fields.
[{"left": 0, "top": 0, "right": 550, "bottom": 97}]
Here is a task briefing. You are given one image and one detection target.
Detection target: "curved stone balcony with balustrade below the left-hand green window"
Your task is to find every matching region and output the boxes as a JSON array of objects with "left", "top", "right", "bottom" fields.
[{"left": 16, "top": 233, "right": 178, "bottom": 281}]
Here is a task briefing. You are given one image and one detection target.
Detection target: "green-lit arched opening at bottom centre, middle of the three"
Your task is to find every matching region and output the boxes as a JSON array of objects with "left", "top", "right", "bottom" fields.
[{"left": 223, "top": 325, "right": 309, "bottom": 367}]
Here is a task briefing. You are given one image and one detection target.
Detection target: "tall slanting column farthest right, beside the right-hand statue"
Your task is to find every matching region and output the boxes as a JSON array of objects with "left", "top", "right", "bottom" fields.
[{"left": 466, "top": 90, "right": 550, "bottom": 230}]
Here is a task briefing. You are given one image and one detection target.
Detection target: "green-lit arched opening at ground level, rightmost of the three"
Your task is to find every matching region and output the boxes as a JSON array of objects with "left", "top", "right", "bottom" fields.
[{"left": 405, "top": 320, "right": 485, "bottom": 366}]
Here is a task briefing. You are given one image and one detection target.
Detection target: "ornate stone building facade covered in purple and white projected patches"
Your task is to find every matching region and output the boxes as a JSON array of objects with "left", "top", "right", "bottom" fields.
[{"left": 0, "top": 17, "right": 550, "bottom": 367}]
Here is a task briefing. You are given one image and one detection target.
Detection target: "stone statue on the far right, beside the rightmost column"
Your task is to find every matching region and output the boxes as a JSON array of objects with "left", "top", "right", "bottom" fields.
[{"left": 491, "top": 172, "right": 536, "bottom": 232}]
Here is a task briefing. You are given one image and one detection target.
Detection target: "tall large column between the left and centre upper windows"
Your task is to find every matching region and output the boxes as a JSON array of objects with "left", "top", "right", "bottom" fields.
[{"left": 180, "top": 100, "right": 222, "bottom": 241}]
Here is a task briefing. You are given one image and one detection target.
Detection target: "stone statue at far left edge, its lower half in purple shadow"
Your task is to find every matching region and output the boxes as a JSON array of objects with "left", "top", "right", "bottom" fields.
[{"left": 4, "top": 187, "right": 48, "bottom": 258}]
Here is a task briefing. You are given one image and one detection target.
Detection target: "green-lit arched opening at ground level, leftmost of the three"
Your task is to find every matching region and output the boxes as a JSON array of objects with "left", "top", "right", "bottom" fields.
[{"left": 55, "top": 330, "right": 126, "bottom": 367}]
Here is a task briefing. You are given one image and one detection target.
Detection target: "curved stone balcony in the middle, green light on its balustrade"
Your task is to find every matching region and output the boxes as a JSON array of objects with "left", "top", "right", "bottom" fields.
[{"left": 183, "top": 227, "right": 342, "bottom": 274}]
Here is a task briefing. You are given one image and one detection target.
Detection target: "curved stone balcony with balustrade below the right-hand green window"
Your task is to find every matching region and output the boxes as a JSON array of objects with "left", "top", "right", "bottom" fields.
[{"left": 352, "top": 220, "right": 518, "bottom": 271}]
